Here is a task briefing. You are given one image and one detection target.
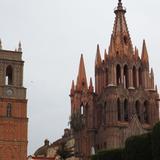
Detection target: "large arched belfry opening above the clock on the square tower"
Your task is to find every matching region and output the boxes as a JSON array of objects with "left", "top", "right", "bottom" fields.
[{"left": 5, "top": 66, "right": 13, "bottom": 85}]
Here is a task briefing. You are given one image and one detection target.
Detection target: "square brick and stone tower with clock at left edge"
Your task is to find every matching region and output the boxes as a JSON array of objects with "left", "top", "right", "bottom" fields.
[{"left": 0, "top": 43, "right": 28, "bottom": 160}]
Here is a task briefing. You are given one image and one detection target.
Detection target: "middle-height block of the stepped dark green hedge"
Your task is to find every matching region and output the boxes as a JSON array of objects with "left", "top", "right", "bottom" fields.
[{"left": 125, "top": 133, "right": 152, "bottom": 160}]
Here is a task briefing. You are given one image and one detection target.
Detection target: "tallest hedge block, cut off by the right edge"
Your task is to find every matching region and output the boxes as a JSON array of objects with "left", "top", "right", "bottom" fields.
[{"left": 152, "top": 122, "right": 160, "bottom": 160}]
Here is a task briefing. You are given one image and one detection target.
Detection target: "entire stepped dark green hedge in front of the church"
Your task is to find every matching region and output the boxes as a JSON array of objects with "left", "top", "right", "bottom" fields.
[{"left": 91, "top": 122, "right": 160, "bottom": 160}]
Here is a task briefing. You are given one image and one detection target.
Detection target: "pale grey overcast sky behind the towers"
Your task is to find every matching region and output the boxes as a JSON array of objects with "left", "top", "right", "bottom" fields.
[{"left": 0, "top": 0, "right": 160, "bottom": 154}]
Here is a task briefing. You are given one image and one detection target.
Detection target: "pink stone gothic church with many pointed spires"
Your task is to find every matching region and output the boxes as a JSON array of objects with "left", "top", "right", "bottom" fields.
[{"left": 70, "top": 0, "right": 159, "bottom": 160}]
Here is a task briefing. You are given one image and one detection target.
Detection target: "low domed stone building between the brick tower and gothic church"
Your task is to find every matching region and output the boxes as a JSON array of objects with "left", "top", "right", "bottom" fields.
[{"left": 31, "top": 128, "right": 78, "bottom": 160}]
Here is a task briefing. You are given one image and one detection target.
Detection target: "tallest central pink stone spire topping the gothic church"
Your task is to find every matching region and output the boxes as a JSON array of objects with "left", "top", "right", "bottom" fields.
[{"left": 110, "top": 0, "right": 133, "bottom": 56}]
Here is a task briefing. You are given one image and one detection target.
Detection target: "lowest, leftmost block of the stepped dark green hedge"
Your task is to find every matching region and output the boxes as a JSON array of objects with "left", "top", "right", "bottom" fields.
[{"left": 91, "top": 149, "right": 124, "bottom": 160}]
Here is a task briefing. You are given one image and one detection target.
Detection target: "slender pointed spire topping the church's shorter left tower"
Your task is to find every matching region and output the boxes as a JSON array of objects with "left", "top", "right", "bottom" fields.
[{"left": 77, "top": 54, "right": 88, "bottom": 90}]
